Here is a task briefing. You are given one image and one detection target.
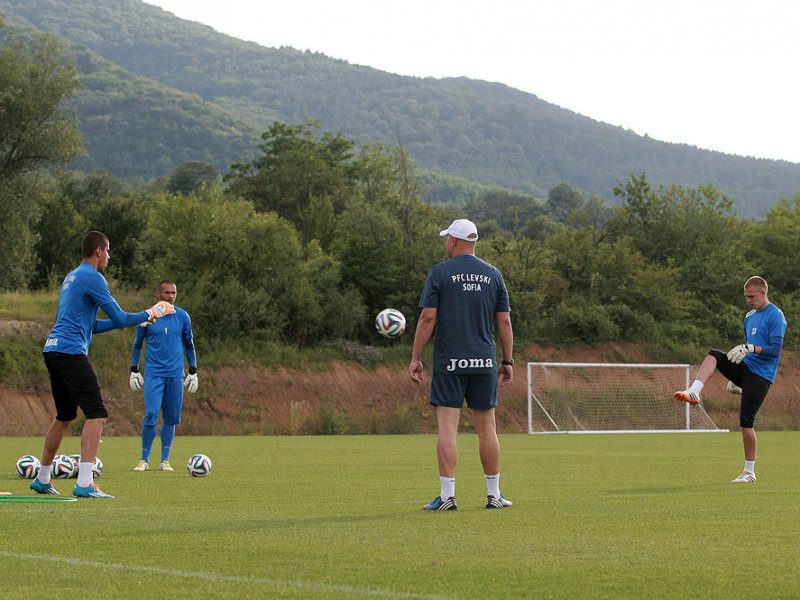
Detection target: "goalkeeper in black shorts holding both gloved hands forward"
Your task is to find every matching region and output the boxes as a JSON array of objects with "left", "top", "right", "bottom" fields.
[{"left": 30, "top": 231, "right": 175, "bottom": 498}]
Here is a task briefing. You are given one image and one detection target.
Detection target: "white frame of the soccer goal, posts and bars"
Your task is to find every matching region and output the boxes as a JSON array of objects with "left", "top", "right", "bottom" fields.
[{"left": 528, "top": 362, "right": 729, "bottom": 434}]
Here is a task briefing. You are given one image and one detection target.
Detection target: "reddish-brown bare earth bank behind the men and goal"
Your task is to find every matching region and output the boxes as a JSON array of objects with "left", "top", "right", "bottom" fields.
[{"left": 0, "top": 344, "right": 800, "bottom": 436}]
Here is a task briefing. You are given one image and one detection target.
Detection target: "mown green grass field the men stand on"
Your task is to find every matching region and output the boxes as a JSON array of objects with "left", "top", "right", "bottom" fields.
[{"left": 0, "top": 432, "right": 800, "bottom": 599}]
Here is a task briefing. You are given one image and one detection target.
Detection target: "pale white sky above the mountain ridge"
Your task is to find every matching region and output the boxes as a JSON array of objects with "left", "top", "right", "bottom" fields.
[{"left": 146, "top": 0, "right": 800, "bottom": 163}]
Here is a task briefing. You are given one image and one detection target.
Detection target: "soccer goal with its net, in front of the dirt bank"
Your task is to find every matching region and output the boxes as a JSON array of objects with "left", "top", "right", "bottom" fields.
[{"left": 528, "top": 362, "right": 727, "bottom": 433}]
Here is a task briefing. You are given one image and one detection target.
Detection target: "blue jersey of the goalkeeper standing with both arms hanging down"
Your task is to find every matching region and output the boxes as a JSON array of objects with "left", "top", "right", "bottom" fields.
[{"left": 131, "top": 306, "right": 197, "bottom": 377}]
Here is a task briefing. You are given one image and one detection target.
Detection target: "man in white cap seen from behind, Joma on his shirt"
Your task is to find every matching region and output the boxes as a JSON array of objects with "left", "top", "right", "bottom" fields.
[{"left": 408, "top": 219, "right": 514, "bottom": 510}]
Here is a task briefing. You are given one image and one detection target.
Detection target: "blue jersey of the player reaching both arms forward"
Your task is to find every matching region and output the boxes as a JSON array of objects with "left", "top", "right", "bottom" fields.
[{"left": 44, "top": 262, "right": 117, "bottom": 355}]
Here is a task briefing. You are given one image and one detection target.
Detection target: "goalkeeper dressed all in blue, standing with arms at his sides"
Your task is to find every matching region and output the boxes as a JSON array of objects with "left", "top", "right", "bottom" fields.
[{"left": 130, "top": 279, "right": 199, "bottom": 471}]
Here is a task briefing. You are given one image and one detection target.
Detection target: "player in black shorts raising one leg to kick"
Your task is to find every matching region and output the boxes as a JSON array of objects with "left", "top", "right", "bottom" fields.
[{"left": 675, "top": 276, "right": 786, "bottom": 483}]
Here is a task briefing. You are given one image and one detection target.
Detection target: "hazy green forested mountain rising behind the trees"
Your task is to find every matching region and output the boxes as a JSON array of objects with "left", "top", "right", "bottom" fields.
[{"left": 0, "top": 0, "right": 800, "bottom": 216}]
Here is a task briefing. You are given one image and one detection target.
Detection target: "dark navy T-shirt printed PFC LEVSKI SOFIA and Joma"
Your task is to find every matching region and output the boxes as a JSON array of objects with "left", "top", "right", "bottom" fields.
[{"left": 419, "top": 254, "right": 511, "bottom": 375}]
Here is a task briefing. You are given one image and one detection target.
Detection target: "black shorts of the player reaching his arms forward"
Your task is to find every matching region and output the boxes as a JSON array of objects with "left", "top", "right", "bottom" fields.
[{"left": 44, "top": 352, "right": 108, "bottom": 421}]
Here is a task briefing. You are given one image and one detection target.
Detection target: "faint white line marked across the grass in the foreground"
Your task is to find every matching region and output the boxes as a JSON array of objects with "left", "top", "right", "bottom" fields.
[{"left": 0, "top": 550, "right": 457, "bottom": 600}]
